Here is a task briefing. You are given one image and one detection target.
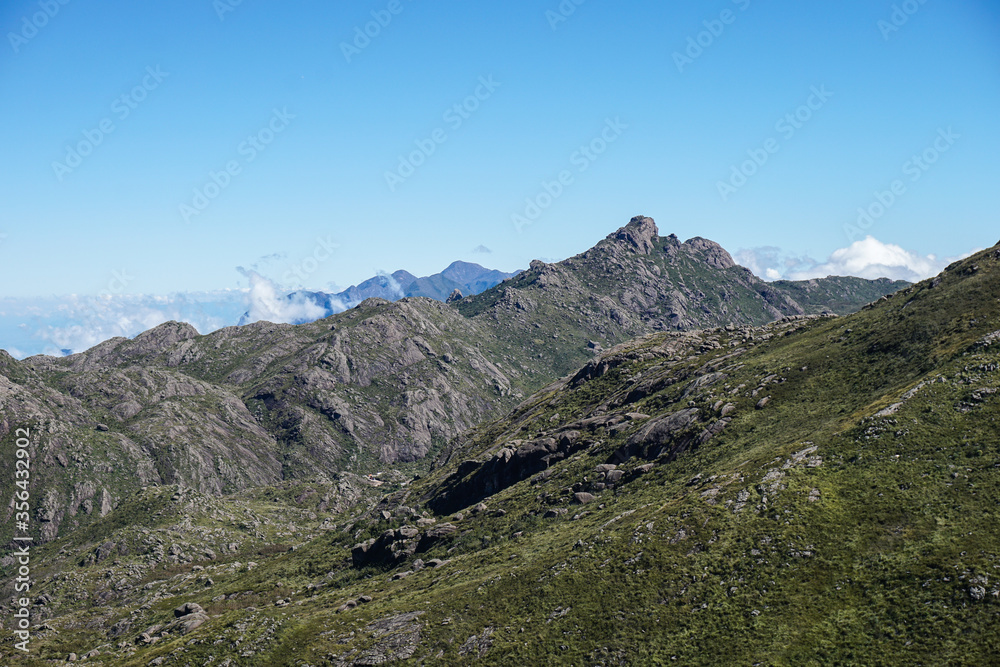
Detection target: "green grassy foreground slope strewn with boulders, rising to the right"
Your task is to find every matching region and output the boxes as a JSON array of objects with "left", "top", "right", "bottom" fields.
[{"left": 0, "top": 237, "right": 1000, "bottom": 665}]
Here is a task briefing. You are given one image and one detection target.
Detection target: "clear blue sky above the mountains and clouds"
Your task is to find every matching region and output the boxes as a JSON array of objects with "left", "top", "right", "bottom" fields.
[{"left": 0, "top": 0, "right": 1000, "bottom": 297}]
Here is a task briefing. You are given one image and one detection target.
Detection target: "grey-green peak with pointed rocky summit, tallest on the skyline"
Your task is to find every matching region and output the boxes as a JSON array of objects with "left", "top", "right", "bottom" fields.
[{"left": 456, "top": 216, "right": 909, "bottom": 375}]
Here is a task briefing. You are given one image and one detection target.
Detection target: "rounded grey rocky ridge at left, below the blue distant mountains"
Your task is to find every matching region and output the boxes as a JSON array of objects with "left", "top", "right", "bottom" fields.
[{"left": 0, "top": 299, "right": 534, "bottom": 539}]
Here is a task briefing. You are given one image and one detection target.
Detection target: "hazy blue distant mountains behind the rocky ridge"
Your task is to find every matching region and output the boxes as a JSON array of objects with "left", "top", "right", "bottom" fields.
[{"left": 239, "top": 262, "right": 520, "bottom": 326}]
